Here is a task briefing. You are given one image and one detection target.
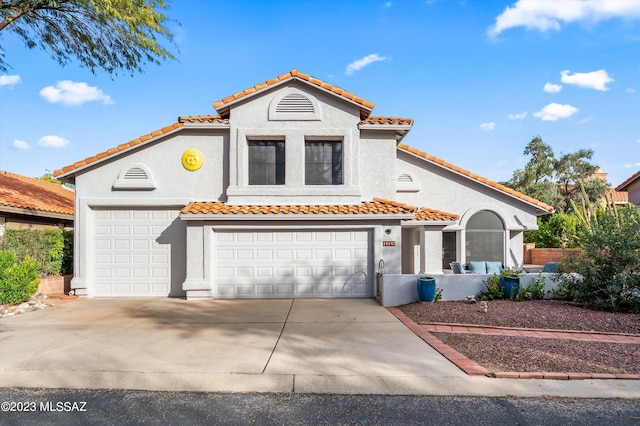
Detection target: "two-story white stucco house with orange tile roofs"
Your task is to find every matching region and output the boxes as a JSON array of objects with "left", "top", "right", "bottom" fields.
[{"left": 55, "top": 69, "right": 552, "bottom": 299}]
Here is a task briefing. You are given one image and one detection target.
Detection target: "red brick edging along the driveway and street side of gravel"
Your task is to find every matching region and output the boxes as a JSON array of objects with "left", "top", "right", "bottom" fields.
[{"left": 387, "top": 307, "right": 640, "bottom": 380}]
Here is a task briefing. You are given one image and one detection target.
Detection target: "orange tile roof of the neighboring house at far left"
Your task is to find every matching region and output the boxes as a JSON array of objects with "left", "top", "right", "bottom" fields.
[{"left": 0, "top": 170, "right": 74, "bottom": 235}]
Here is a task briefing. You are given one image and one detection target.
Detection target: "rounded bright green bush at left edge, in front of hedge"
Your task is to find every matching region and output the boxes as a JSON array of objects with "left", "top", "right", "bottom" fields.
[{"left": 0, "top": 250, "right": 40, "bottom": 304}]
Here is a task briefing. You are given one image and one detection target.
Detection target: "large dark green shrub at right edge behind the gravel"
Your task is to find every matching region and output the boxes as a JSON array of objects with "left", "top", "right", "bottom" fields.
[{"left": 554, "top": 199, "right": 640, "bottom": 313}]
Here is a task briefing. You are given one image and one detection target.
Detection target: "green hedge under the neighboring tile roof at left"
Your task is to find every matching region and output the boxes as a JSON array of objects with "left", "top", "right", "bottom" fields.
[{"left": 0, "top": 229, "right": 64, "bottom": 275}]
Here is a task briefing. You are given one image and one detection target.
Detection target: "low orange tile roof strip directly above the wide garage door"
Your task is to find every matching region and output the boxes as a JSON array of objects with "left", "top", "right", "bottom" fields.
[{"left": 180, "top": 198, "right": 458, "bottom": 221}]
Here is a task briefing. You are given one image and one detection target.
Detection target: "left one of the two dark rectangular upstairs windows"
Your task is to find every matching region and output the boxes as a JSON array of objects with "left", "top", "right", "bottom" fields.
[{"left": 249, "top": 141, "right": 284, "bottom": 185}]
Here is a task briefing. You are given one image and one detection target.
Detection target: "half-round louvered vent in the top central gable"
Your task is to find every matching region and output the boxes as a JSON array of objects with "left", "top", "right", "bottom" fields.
[{"left": 269, "top": 87, "right": 322, "bottom": 121}]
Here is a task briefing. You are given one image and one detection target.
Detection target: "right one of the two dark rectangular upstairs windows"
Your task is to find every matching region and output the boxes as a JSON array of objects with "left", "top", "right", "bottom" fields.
[{"left": 304, "top": 141, "right": 343, "bottom": 185}]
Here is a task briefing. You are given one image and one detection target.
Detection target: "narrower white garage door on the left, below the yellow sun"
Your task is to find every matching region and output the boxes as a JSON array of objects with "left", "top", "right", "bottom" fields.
[{"left": 94, "top": 209, "right": 179, "bottom": 296}]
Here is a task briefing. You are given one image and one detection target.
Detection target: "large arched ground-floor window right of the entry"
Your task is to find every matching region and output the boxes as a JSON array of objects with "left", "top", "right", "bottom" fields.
[{"left": 466, "top": 210, "right": 504, "bottom": 264}]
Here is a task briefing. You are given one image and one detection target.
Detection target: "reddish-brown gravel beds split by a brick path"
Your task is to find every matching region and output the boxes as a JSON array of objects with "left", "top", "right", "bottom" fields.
[{"left": 399, "top": 300, "right": 640, "bottom": 374}]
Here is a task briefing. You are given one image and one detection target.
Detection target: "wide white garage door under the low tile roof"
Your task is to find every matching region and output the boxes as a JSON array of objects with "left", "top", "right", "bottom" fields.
[{"left": 213, "top": 230, "right": 373, "bottom": 298}]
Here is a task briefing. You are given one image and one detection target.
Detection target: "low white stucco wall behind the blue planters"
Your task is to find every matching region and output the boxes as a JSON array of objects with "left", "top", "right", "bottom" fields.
[{"left": 379, "top": 273, "right": 558, "bottom": 306}]
